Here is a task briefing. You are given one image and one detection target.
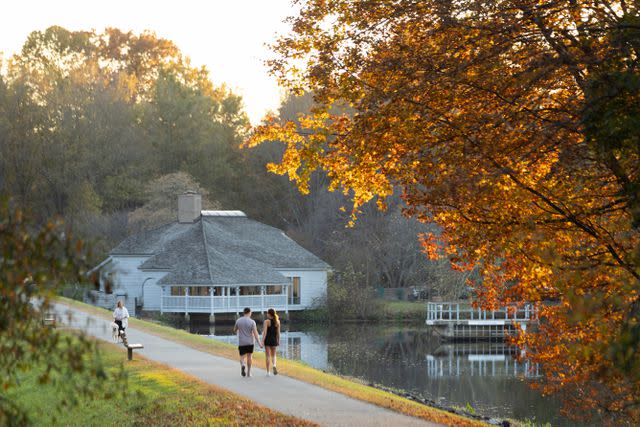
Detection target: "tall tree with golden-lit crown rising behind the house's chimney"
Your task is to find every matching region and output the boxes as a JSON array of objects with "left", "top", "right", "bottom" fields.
[{"left": 143, "top": 71, "right": 248, "bottom": 204}]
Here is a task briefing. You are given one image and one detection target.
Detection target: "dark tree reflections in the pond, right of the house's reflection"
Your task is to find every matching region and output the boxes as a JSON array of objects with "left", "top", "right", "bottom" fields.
[{"left": 327, "top": 325, "right": 562, "bottom": 425}]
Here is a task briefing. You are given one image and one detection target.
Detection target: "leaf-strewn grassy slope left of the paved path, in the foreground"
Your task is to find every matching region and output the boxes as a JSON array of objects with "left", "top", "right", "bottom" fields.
[{"left": 9, "top": 343, "right": 315, "bottom": 427}]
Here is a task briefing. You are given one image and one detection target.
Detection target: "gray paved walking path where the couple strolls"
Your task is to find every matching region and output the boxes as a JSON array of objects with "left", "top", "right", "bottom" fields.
[{"left": 56, "top": 304, "right": 439, "bottom": 426}]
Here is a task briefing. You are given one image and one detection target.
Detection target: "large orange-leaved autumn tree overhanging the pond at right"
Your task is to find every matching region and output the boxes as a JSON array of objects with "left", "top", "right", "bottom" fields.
[{"left": 250, "top": 0, "right": 640, "bottom": 421}]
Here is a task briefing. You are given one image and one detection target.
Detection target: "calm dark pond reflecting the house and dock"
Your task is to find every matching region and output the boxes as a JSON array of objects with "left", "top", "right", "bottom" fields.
[{"left": 178, "top": 320, "right": 578, "bottom": 426}]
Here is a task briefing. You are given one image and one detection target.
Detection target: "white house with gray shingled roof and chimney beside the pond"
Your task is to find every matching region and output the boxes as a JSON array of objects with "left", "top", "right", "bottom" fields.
[{"left": 96, "top": 192, "right": 330, "bottom": 315}]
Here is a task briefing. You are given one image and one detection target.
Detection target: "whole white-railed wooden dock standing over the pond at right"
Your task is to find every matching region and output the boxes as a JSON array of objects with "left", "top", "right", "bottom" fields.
[{"left": 426, "top": 302, "right": 538, "bottom": 341}]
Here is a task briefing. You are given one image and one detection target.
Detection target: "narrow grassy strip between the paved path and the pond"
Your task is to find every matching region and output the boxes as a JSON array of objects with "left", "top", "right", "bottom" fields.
[{"left": 60, "top": 298, "right": 485, "bottom": 426}]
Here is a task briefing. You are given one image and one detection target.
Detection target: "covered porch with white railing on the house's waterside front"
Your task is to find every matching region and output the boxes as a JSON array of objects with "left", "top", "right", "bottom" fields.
[{"left": 160, "top": 284, "right": 300, "bottom": 315}]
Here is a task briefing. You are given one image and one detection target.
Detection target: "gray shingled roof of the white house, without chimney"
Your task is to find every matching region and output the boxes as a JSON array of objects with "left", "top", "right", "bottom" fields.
[{"left": 110, "top": 215, "right": 329, "bottom": 285}]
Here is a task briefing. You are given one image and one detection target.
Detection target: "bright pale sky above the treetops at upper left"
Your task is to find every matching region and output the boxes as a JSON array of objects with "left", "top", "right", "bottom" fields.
[{"left": 0, "top": 0, "right": 294, "bottom": 124}]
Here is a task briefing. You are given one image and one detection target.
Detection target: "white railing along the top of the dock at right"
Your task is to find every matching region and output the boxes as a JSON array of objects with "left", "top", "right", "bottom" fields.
[{"left": 427, "top": 302, "right": 538, "bottom": 324}]
